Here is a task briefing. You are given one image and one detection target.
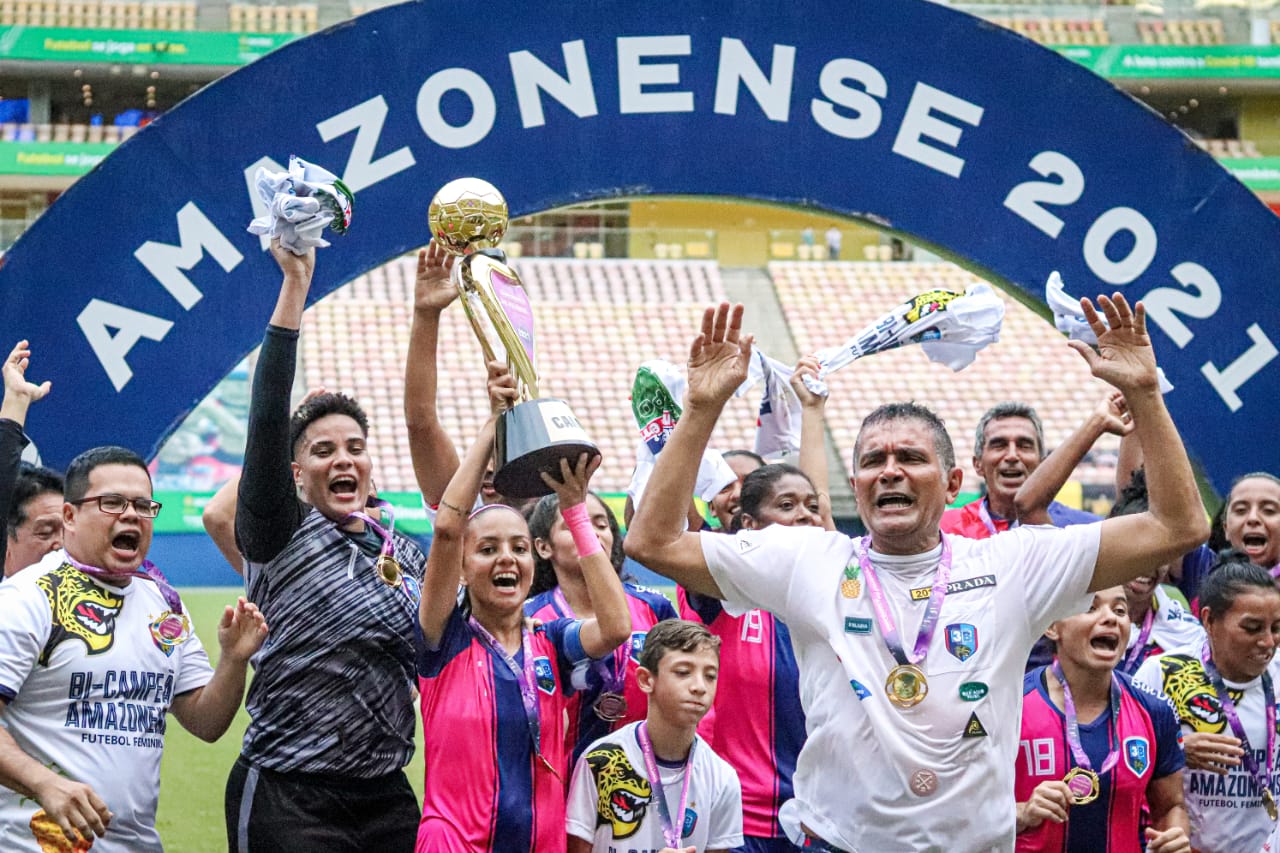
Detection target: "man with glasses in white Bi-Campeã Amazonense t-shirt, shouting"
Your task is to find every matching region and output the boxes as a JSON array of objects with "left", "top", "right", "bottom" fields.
[{"left": 0, "top": 447, "right": 266, "bottom": 853}]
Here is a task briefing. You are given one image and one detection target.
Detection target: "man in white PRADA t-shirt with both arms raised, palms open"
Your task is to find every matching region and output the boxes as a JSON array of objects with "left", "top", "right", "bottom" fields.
[{"left": 626, "top": 296, "right": 1208, "bottom": 853}]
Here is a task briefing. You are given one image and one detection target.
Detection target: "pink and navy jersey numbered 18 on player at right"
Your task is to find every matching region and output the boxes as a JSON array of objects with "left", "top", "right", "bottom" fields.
[{"left": 1014, "top": 667, "right": 1185, "bottom": 853}]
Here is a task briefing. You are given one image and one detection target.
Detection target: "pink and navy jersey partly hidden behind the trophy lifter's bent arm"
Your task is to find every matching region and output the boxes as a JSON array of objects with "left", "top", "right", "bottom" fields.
[{"left": 525, "top": 583, "right": 676, "bottom": 758}]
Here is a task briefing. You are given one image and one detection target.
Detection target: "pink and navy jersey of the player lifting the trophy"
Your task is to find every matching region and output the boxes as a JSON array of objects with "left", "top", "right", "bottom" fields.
[{"left": 416, "top": 607, "right": 590, "bottom": 853}]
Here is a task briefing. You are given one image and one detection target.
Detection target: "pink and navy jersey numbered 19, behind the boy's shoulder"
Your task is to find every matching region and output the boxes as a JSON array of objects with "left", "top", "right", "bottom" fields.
[{"left": 677, "top": 588, "right": 805, "bottom": 839}]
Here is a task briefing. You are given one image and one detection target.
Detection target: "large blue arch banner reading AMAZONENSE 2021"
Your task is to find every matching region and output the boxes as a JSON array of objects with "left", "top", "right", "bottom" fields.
[{"left": 0, "top": 0, "right": 1280, "bottom": 488}]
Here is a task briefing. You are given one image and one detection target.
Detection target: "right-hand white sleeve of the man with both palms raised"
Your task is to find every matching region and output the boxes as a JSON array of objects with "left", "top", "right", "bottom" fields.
[{"left": 998, "top": 523, "right": 1102, "bottom": 637}]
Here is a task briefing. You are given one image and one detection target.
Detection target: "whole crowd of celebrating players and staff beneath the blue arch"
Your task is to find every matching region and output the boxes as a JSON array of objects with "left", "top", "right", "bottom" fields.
[{"left": 0, "top": 234, "right": 1280, "bottom": 853}]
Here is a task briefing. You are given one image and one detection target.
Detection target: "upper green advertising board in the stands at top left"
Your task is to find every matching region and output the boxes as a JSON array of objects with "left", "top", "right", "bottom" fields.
[{"left": 0, "top": 27, "right": 297, "bottom": 65}]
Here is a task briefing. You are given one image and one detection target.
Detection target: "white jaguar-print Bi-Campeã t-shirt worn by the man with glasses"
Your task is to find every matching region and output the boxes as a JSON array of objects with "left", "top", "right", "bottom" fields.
[{"left": 0, "top": 551, "right": 214, "bottom": 853}]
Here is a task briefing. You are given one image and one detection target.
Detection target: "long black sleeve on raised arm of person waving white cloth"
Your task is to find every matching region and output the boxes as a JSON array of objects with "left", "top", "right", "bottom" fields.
[{"left": 236, "top": 325, "right": 306, "bottom": 562}]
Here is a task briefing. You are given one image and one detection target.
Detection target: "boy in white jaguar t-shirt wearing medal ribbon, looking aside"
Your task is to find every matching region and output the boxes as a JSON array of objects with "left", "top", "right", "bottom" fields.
[{"left": 568, "top": 619, "right": 742, "bottom": 853}]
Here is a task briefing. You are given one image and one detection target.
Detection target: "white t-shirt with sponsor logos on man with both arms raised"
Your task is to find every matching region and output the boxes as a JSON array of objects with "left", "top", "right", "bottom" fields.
[{"left": 701, "top": 524, "right": 1100, "bottom": 853}]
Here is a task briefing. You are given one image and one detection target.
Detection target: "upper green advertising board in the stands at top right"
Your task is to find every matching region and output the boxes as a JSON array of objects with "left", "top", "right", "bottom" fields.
[{"left": 1055, "top": 45, "right": 1280, "bottom": 79}]
